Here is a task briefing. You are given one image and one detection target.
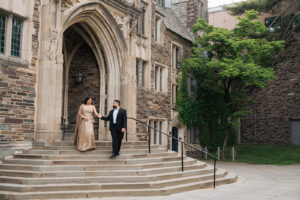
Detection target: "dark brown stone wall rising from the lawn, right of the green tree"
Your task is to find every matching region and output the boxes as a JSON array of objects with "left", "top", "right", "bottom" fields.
[{"left": 241, "top": 34, "right": 300, "bottom": 144}]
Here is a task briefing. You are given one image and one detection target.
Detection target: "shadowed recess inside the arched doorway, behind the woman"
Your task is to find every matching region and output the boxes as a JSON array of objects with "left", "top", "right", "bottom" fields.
[{"left": 62, "top": 23, "right": 102, "bottom": 140}]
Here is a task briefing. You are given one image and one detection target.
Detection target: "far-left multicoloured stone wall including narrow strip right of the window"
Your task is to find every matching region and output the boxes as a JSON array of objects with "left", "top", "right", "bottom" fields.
[{"left": 0, "top": 0, "right": 40, "bottom": 142}]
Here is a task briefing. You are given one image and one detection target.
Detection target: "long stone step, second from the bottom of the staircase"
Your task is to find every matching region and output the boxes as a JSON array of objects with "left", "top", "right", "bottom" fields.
[{"left": 0, "top": 167, "right": 217, "bottom": 185}]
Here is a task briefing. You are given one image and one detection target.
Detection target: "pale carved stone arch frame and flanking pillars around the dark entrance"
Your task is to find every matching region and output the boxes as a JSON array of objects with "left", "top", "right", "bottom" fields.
[{"left": 35, "top": 2, "right": 136, "bottom": 143}]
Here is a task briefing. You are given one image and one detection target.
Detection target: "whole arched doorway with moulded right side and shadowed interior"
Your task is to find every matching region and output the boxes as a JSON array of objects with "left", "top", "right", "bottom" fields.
[{"left": 59, "top": 2, "right": 127, "bottom": 140}]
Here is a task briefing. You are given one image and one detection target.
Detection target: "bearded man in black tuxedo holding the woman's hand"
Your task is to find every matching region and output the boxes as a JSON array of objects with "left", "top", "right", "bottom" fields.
[{"left": 99, "top": 100, "right": 127, "bottom": 158}]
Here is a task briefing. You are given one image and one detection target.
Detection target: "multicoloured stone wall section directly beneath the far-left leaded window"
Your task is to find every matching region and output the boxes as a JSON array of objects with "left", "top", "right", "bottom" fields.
[{"left": 0, "top": 60, "right": 36, "bottom": 141}]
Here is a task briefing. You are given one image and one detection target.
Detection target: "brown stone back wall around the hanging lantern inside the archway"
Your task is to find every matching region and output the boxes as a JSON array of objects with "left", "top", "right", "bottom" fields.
[{"left": 68, "top": 43, "right": 100, "bottom": 125}]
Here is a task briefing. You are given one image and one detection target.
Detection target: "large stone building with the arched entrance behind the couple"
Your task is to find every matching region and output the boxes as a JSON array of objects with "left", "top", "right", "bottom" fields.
[{"left": 0, "top": 0, "right": 207, "bottom": 150}]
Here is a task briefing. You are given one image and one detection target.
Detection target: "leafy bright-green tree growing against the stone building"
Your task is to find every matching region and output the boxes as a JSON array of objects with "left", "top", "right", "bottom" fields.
[{"left": 176, "top": 10, "right": 283, "bottom": 158}]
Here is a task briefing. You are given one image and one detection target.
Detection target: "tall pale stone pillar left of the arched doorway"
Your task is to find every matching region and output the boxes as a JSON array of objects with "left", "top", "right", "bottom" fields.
[{"left": 35, "top": 2, "right": 63, "bottom": 143}]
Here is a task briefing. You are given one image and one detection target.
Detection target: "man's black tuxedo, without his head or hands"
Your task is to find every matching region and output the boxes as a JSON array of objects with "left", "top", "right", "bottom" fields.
[{"left": 101, "top": 108, "right": 127, "bottom": 155}]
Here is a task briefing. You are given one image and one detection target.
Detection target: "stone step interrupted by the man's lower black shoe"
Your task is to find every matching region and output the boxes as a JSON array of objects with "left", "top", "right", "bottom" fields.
[{"left": 14, "top": 151, "right": 178, "bottom": 160}]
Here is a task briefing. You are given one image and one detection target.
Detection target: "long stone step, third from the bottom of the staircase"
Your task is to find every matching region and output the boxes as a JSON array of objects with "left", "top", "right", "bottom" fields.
[{"left": 0, "top": 163, "right": 206, "bottom": 178}]
